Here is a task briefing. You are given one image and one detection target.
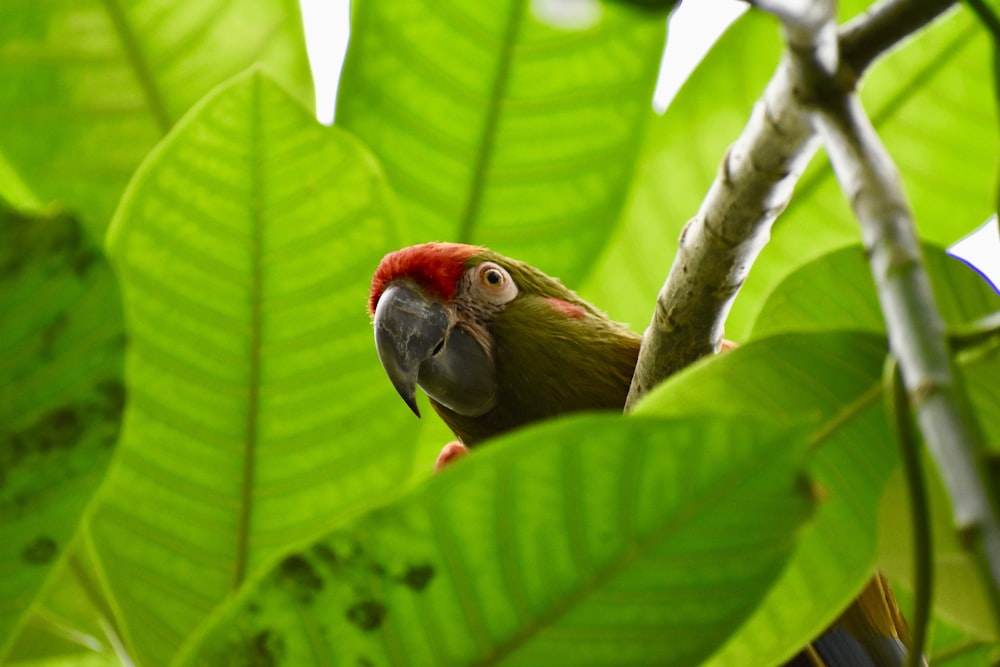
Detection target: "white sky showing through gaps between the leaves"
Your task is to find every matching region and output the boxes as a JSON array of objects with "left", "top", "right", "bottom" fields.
[{"left": 300, "top": 0, "right": 1000, "bottom": 286}]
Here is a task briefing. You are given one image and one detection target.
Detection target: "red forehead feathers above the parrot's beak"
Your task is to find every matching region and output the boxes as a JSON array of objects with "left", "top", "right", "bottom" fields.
[{"left": 368, "top": 243, "right": 482, "bottom": 315}]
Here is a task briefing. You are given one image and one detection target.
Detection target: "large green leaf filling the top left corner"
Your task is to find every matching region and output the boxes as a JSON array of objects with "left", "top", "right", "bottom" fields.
[{"left": 0, "top": 0, "right": 312, "bottom": 238}]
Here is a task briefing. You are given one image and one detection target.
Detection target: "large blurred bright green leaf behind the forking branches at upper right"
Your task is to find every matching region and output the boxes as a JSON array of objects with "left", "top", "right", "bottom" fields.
[{"left": 581, "top": 3, "right": 997, "bottom": 340}]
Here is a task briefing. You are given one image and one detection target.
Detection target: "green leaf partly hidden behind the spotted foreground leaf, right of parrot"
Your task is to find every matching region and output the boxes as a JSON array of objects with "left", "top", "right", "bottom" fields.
[{"left": 636, "top": 332, "right": 898, "bottom": 666}]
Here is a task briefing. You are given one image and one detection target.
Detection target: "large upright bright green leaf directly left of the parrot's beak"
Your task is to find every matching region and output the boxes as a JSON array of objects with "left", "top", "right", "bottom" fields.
[{"left": 84, "top": 71, "right": 415, "bottom": 664}]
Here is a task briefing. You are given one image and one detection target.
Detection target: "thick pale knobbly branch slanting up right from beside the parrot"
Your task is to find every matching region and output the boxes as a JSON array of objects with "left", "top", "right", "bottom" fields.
[{"left": 626, "top": 0, "right": 954, "bottom": 410}]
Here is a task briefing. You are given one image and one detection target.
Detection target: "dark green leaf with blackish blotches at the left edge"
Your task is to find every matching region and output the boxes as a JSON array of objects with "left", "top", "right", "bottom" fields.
[{"left": 0, "top": 203, "right": 125, "bottom": 661}]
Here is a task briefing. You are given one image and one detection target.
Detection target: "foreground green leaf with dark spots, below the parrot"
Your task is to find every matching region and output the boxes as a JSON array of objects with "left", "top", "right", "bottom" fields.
[{"left": 182, "top": 415, "right": 811, "bottom": 665}]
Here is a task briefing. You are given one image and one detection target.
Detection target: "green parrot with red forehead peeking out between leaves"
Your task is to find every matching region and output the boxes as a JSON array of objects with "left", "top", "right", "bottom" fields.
[{"left": 368, "top": 242, "right": 909, "bottom": 667}]
